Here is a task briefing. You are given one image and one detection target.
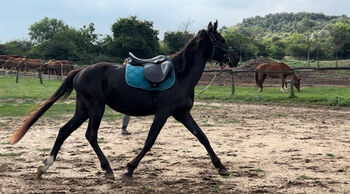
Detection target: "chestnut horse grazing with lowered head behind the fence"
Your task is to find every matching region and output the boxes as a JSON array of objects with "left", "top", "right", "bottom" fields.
[{"left": 255, "top": 62, "right": 301, "bottom": 92}]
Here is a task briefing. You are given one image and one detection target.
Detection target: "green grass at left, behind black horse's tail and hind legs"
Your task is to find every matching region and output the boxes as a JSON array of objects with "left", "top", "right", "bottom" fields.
[{"left": 0, "top": 76, "right": 122, "bottom": 120}]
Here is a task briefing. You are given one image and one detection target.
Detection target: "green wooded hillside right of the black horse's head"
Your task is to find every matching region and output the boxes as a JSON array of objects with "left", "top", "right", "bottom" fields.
[{"left": 222, "top": 12, "right": 350, "bottom": 66}]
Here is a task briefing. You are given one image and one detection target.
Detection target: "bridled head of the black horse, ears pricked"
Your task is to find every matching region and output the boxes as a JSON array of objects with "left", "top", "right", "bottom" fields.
[{"left": 206, "top": 21, "right": 239, "bottom": 67}]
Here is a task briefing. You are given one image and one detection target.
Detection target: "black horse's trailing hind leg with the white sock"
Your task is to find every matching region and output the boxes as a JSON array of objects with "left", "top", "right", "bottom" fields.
[{"left": 37, "top": 106, "right": 87, "bottom": 177}]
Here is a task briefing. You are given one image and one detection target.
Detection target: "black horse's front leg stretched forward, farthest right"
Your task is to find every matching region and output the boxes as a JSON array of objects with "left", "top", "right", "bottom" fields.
[{"left": 174, "top": 111, "right": 229, "bottom": 176}]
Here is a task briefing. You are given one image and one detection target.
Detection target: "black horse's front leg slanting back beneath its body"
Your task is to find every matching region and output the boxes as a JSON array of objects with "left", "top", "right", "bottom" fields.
[{"left": 123, "top": 114, "right": 169, "bottom": 179}]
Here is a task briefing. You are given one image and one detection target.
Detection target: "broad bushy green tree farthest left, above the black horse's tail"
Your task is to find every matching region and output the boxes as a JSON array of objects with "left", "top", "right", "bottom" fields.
[{"left": 29, "top": 17, "right": 99, "bottom": 60}]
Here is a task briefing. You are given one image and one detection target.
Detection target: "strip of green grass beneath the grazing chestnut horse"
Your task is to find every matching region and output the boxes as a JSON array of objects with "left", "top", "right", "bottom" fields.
[{"left": 195, "top": 86, "right": 350, "bottom": 107}]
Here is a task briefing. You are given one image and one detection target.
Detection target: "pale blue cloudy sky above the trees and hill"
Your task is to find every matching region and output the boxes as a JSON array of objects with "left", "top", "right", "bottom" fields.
[{"left": 0, "top": 0, "right": 350, "bottom": 43}]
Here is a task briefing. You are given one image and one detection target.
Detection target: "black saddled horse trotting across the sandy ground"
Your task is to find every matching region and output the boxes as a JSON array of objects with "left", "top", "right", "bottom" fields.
[{"left": 9, "top": 21, "right": 238, "bottom": 179}]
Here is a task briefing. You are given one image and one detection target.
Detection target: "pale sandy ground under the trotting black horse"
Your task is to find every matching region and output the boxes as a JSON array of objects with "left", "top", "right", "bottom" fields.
[{"left": 0, "top": 102, "right": 350, "bottom": 193}]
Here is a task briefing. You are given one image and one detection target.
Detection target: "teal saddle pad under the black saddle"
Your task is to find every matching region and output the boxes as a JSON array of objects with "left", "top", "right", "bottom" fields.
[{"left": 125, "top": 64, "right": 175, "bottom": 91}]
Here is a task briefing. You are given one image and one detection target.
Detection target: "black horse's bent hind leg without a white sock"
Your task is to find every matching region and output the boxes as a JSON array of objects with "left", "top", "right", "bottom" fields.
[{"left": 85, "top": 102, "right": 114, "bottom": 179}]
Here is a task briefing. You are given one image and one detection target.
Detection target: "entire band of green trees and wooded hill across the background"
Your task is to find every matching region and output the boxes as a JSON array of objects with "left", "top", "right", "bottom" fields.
[{"left": 0, "top": 12, "right": 350, "bottom": 66}]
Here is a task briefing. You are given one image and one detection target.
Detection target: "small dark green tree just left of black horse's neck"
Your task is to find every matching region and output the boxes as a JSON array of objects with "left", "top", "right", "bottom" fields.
[{"left": 163, "top": 31, "right": 194, "bottom": 54}]
